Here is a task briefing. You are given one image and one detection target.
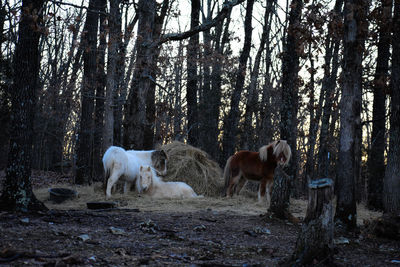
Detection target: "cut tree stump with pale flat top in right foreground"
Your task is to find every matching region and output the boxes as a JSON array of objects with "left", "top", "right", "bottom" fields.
[{"left": 292, "top": 178, "right": 334, "bottom": 265}]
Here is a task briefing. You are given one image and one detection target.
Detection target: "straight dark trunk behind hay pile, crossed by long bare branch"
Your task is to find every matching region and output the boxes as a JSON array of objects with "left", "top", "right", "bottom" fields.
[{"left": 186, "top": 0, "right": 200, "bottom": 146}]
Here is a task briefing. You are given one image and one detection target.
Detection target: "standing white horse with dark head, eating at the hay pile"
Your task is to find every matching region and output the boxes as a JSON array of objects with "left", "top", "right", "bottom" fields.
[{"left": 103, "top": 146, "right": 168, "bottom": 198}]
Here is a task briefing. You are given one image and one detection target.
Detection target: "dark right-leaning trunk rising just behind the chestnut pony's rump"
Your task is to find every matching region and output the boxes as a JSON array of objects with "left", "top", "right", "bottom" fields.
[{"left": 221, "top": 0, "right": 254, "bottom": 162}]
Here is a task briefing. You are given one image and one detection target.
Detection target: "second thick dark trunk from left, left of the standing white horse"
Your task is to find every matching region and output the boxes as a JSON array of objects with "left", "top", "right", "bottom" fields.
[{"left": 75, "top": 0, "right": 99, "bottom": 184}]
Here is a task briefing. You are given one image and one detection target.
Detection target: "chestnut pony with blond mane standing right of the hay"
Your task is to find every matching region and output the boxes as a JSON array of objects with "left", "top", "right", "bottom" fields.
[{"left": 224, "top": 140, "right": 292, "bottom": 203}]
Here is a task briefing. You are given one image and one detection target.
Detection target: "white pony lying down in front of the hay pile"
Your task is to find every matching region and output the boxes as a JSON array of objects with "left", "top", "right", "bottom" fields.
[{"left": 136, "top": 166, "right": 202, "bottom": 198}]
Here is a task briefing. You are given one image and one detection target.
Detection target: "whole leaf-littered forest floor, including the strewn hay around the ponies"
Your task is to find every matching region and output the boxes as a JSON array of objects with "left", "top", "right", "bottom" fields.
[{"left": 0, "top": 172, "right": 400, "bottom": 266}]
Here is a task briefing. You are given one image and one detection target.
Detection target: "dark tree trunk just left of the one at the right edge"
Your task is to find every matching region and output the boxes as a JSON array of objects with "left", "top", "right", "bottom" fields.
[{"left": 367, "top": 0, "right": 393, "bottom": 210}]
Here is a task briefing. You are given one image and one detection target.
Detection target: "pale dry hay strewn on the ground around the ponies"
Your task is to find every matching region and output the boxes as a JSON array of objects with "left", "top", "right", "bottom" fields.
[{"left": 33, "top": 183, "right": 382, "bottom": 226}]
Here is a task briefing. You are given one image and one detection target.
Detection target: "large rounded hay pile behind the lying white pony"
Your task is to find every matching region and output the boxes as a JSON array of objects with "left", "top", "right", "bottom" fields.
[{"left": 161, "top": 141, "right": 224, "bottom": 197}]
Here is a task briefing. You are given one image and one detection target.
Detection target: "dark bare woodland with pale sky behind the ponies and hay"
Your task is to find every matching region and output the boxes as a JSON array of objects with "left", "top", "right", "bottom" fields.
[{"left": 0, "top": 0, "right": 400, "bottom": 228}]
